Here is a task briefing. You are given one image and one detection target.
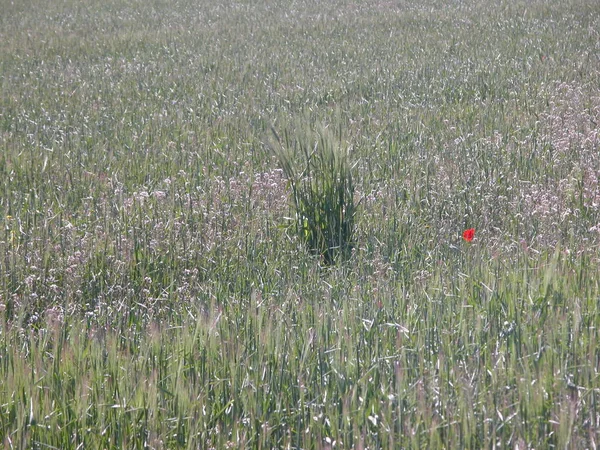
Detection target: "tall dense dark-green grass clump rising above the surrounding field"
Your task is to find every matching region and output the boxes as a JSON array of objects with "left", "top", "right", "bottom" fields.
[{"left": 274, "top": 125, "right": 357, "bottom": 265}]
